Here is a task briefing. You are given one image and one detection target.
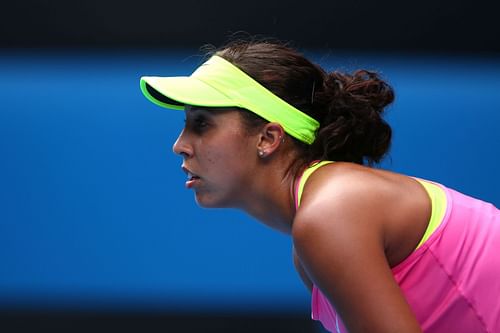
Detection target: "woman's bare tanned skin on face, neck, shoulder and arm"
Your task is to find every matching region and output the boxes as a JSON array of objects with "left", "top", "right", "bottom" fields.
[{"left": 173, "top": 107, "right": 431, "bottom": 333}]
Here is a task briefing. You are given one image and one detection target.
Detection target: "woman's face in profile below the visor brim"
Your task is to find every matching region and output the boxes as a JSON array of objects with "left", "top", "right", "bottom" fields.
[{"left": 173, "top": 106, "right": 257, "bottom": 207}]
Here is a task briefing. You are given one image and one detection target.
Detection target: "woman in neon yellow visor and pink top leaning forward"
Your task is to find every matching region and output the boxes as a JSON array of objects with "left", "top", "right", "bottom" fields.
[{"left": 141, "top": 42, "right": 500, "bottom": 332}]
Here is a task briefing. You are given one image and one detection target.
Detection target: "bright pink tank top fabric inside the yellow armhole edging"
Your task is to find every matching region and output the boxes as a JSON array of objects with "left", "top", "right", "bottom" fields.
[{"left": 294, "top": 162, "right": 500, "bottom": 333}]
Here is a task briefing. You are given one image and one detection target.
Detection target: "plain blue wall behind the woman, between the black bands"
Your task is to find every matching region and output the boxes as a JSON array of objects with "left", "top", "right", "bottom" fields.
[{"left": 0, "top": 51, "right": 500, "bottom": 311}]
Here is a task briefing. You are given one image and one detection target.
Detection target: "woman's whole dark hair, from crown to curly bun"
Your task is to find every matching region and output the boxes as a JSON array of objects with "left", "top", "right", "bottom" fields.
[{"left": 209, "top": 41, "right": 394, "bottom": 164}]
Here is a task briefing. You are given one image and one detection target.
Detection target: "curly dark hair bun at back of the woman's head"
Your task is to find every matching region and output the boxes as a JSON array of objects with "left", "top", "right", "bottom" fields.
[{"left": 314, "top": 70, "right": 394, "bottom": 164}]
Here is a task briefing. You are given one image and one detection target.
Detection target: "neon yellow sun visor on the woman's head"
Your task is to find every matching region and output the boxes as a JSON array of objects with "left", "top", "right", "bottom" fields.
[{"left": 141, "top": 56, "right": 319, "bottom": 144}]
